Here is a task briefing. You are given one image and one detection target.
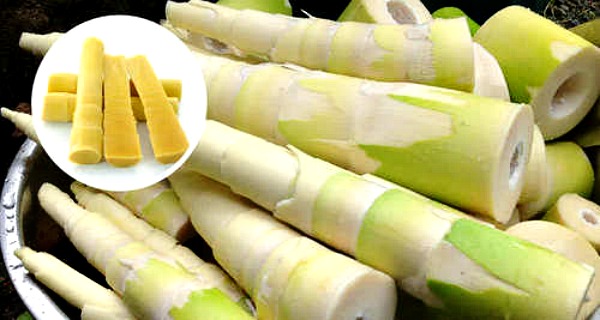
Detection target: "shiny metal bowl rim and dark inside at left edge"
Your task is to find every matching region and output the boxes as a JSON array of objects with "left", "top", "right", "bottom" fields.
[{"left": 0, "top": 140, "right": 91, "bottom": 319}]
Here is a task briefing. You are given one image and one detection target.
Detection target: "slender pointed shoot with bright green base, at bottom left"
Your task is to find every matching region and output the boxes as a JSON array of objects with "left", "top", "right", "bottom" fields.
[{"left": 38, "top": 183, "right": 252, "bottom": 320}]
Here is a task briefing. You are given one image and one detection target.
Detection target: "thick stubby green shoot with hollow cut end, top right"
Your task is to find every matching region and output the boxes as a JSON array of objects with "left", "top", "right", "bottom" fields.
[{"left": 474, "top": 6, "right": 600, "bottom": 140}]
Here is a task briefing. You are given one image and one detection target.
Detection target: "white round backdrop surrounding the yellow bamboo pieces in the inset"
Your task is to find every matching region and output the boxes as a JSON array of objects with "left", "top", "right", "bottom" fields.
[{"left": 31, "top": 15, "right": 207, "bottom": 191}]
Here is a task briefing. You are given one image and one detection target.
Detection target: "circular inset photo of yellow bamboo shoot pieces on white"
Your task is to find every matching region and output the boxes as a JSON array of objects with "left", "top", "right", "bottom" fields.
[{"left": 31, "top": 15, "right": 207, "bottom": 191}]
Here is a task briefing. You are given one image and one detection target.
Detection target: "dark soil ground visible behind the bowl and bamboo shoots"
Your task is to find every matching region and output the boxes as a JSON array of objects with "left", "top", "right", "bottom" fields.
[{"left": 0, "top": 0, "right": 600, "bottom": 319}]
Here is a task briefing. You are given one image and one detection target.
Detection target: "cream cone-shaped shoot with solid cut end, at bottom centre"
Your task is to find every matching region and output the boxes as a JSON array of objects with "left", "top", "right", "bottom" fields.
[{"left": 169, "top": 171, "right": 396, "bottom": 320}]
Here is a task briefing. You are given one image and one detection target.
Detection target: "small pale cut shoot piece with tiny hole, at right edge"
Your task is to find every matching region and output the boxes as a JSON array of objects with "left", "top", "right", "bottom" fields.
[{"left": 543, "top": 193, "right": 600, "bottom": 251}]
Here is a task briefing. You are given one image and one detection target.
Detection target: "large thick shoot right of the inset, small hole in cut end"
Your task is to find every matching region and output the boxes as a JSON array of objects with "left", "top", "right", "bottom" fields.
[{"left": 197, "top": 54, "right": 533, "bottom": 223}]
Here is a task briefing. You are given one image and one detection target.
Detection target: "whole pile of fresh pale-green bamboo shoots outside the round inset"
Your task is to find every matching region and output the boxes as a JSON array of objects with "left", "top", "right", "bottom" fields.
[{"left": 2, "top": 0, "right": 600, "bottom": 320}]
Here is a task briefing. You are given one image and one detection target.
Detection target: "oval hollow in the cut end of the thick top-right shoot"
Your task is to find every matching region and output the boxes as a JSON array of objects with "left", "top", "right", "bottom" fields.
[{"left": 550, "top": 73, "right": 589, "bottom": 118}]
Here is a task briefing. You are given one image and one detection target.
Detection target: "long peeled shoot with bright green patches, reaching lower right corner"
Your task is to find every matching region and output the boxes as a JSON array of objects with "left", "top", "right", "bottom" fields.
[{"left": 180, "top": 121, "right": 593, "bottom": 319}]
